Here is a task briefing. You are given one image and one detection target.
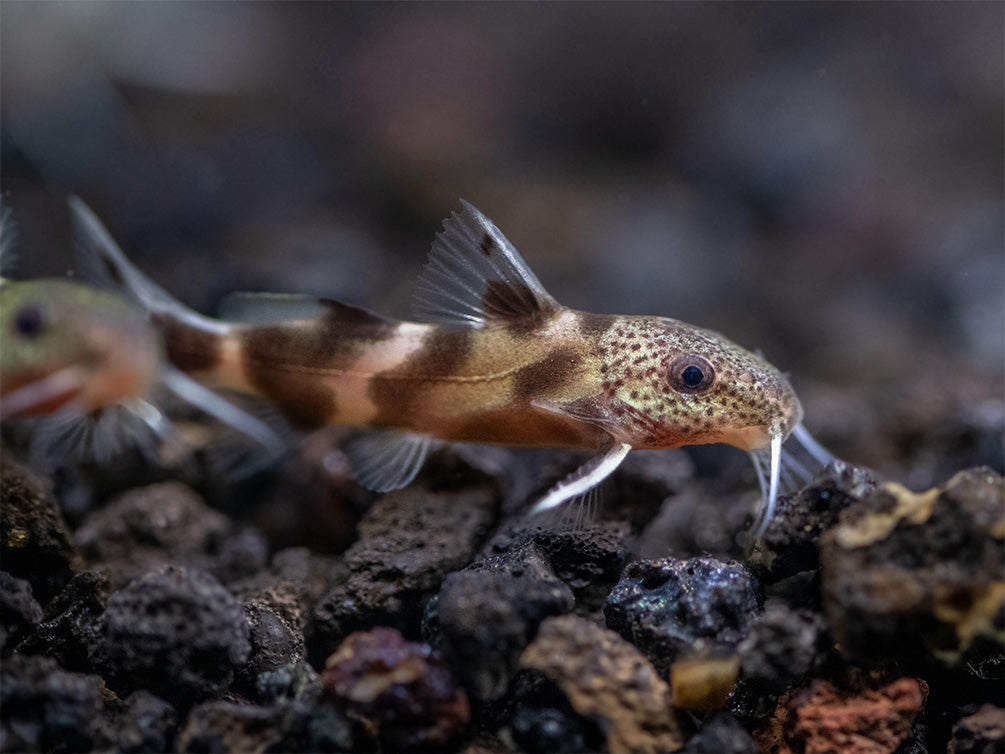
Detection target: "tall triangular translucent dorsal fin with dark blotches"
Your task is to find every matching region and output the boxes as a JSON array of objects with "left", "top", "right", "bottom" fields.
[{"left": 414, "top": 199, "right": 562, "bottom": 328}]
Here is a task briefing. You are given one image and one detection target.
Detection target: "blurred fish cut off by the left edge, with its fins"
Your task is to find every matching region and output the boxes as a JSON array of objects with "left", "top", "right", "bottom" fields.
[{"left": 0, "top": 209, "right": 282, "bottom": 470}]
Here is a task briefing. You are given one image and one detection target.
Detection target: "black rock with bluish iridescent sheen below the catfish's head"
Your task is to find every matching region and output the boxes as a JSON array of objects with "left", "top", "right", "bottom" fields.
[{"left": 604, "top": 558, "right": 758, "bottom": 679}]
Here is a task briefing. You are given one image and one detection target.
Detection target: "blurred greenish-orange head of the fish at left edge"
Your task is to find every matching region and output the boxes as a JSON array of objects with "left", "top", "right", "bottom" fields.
[{"left": 0, "top": 279, "right": 161, "bottom": 416}]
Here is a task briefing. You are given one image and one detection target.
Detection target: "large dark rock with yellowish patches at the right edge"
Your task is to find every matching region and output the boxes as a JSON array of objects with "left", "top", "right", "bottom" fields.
[{"left": 820, "top": 467, "right": 1005, "bottom": 678}]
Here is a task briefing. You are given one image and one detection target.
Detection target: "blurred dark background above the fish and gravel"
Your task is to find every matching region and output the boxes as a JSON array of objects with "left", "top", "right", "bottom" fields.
[{"left": 0, "top": 0, "right": 1005, "bottom": 486}]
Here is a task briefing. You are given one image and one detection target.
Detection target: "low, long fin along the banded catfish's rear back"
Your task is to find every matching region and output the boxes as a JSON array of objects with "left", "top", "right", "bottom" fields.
[{"left": 220, "top": 293, "right": 391, "bottom": 326}]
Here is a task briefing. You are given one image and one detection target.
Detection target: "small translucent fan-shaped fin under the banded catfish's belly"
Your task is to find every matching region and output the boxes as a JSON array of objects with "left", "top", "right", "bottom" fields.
[{"left": 345, "top": 430, "right": 432, "bottom": 493}]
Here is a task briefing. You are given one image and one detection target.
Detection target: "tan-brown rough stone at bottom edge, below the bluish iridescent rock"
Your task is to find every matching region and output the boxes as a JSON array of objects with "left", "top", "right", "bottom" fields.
[{"left": 521, "top": 615, "right": 684, "bottom": 752}]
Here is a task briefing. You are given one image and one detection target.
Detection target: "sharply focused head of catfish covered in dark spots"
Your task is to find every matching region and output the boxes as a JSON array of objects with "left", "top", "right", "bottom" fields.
[{"left": 599, "top": 317, "right": 803, "bottom": 450}]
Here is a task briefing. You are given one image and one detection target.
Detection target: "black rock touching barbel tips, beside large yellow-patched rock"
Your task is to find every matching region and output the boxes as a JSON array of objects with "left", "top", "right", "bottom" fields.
[{"left": 748, "top": 460, "right": 876, "bottom": 584}]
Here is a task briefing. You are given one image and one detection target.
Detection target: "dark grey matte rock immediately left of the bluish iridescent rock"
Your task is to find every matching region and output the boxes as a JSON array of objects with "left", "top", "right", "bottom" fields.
[{"left": 423, "top": 548, "right": 575, "bottom": 700}]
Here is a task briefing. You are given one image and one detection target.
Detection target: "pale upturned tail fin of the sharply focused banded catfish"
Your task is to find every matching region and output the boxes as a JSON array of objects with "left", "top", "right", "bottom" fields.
[{"left": 68, "top": 196, "right": 227, "bottom": 333}]
